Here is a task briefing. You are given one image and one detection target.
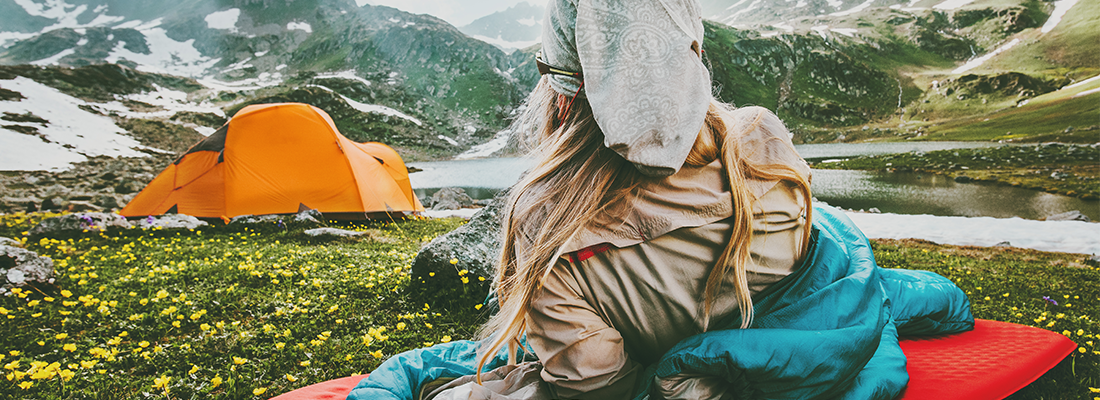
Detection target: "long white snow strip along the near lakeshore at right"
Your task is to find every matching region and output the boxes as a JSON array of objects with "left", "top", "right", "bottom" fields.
[{"left": 847, "top": 212, "right": 1100, "bottom": 254}]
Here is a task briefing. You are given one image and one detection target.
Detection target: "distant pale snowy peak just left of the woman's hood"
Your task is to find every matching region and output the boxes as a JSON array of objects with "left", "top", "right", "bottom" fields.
[{"left": 460, "top": 2, "right": 545, "bottom": 53}]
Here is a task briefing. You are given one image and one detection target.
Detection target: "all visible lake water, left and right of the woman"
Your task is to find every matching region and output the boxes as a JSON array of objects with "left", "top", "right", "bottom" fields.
[{"left": 409, "top": 142, "right": 1100, "bottom": 221}]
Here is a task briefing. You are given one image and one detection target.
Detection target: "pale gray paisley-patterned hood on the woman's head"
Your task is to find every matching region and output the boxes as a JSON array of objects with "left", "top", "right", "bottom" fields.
[{"left": 542, "top": 0, "right": 712, "bottom": 176}]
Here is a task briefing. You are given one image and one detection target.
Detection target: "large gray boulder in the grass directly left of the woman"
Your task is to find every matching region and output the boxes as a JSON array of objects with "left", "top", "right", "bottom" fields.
[{"left": 413, "top": 193, "right": 507, "bottom": 285}]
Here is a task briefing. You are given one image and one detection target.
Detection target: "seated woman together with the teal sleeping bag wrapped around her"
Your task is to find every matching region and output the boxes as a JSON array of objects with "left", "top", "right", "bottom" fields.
[{"left": 352, "top": 0, "right": 972, "bottom": 399}]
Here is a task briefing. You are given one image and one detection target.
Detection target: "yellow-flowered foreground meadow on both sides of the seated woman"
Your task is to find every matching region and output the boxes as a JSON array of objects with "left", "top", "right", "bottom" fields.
[{"left": 0, "top": 214, "right": 1100, "bottom": 399}]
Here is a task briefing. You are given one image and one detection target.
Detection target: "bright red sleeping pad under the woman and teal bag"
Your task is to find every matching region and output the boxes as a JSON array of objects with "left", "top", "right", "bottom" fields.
[{"left": 268, "top": 320, "right": 1077, "bottom": 400}]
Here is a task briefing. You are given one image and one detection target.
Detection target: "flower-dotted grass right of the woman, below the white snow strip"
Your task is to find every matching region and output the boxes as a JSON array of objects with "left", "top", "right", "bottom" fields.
[{"left": 872, "top": 240, "right": 1100, "bottom": 399}]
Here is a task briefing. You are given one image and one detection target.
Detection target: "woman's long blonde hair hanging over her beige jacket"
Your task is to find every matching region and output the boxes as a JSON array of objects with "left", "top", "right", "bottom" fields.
[{"left": 477, "top": 78, "right": 811, "bottom": 382}]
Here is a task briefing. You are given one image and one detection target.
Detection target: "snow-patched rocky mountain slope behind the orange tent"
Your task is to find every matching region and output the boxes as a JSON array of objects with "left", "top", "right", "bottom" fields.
[{"left": 0, "top": 0, "right": 534, "bottom": 168}]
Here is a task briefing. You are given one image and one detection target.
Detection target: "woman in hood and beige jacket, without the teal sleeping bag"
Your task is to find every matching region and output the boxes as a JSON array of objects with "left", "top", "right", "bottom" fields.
[{"left": 451, "top": 0, "right": 810, "bottom": 398}]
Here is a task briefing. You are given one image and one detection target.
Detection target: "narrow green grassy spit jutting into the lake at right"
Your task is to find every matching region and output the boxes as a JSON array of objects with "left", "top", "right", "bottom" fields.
[{"left": 814, "top": 145, "right": 1100, "bottom": 199}]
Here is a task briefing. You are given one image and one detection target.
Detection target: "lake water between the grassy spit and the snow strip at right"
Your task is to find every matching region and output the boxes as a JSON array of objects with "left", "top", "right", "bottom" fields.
[{"left": 812, "top": 169, "right": 1100, "bottom": 220}]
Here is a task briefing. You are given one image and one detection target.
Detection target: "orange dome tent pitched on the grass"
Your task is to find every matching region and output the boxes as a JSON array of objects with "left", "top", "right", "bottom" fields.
[{"left": 119, "top": 103, "right": 424, "bottom": 219}]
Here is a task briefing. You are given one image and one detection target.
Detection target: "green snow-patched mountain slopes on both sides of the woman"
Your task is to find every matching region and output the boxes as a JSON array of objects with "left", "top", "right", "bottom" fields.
[{"left": 0, "top": 0, "right": 1100, "bottom": 169}]
